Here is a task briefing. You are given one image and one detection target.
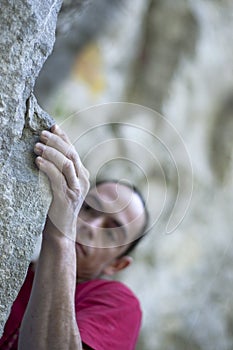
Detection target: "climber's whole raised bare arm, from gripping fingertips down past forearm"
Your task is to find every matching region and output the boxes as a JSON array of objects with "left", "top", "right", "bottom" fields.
[{"left": 19, "top": 127, "right": 89, "bottom": 350}]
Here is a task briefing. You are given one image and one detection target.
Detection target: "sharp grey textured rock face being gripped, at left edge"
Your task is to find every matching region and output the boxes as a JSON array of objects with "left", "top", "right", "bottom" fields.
[{"left": 0, "top": 0, "right": 62, "bottom": 334}]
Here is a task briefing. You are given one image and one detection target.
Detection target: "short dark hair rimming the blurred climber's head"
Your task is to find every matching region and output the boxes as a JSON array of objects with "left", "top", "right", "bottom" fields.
[{"left": 91, "top": 179, "right": 150, "bottom": 258}]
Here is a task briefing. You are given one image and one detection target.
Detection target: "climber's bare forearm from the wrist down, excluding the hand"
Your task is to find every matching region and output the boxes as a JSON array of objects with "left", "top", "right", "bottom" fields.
[{"left": 19, "top": 221, "right": 82, "bottom": 350}]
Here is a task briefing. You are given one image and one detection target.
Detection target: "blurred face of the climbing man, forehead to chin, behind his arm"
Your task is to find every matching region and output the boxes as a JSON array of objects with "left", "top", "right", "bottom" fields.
[{"left": 76, "top": 182, "right": 145, "bottom": 280}]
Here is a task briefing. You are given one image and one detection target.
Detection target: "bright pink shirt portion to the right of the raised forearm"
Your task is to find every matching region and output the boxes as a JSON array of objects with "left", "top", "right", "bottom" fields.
[{"left": 75, "top": 280, "right": 141, "bottom": 350}]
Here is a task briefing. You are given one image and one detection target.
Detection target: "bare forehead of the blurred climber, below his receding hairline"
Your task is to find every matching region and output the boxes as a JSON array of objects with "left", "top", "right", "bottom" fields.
[{"left": 87, "top": 182, "right": 145, "bottom": 237}]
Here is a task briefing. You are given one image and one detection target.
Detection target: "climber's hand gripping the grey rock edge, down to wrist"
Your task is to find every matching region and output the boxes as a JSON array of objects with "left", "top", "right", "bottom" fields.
[{"left": 35, "top": 125, "right": 89, "bottom": 240}]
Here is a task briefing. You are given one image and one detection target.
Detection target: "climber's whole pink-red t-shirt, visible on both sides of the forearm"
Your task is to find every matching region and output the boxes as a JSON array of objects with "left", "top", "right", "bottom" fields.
[{"left": 0, "top": 268, "right": 141, "bottom": 350}]
